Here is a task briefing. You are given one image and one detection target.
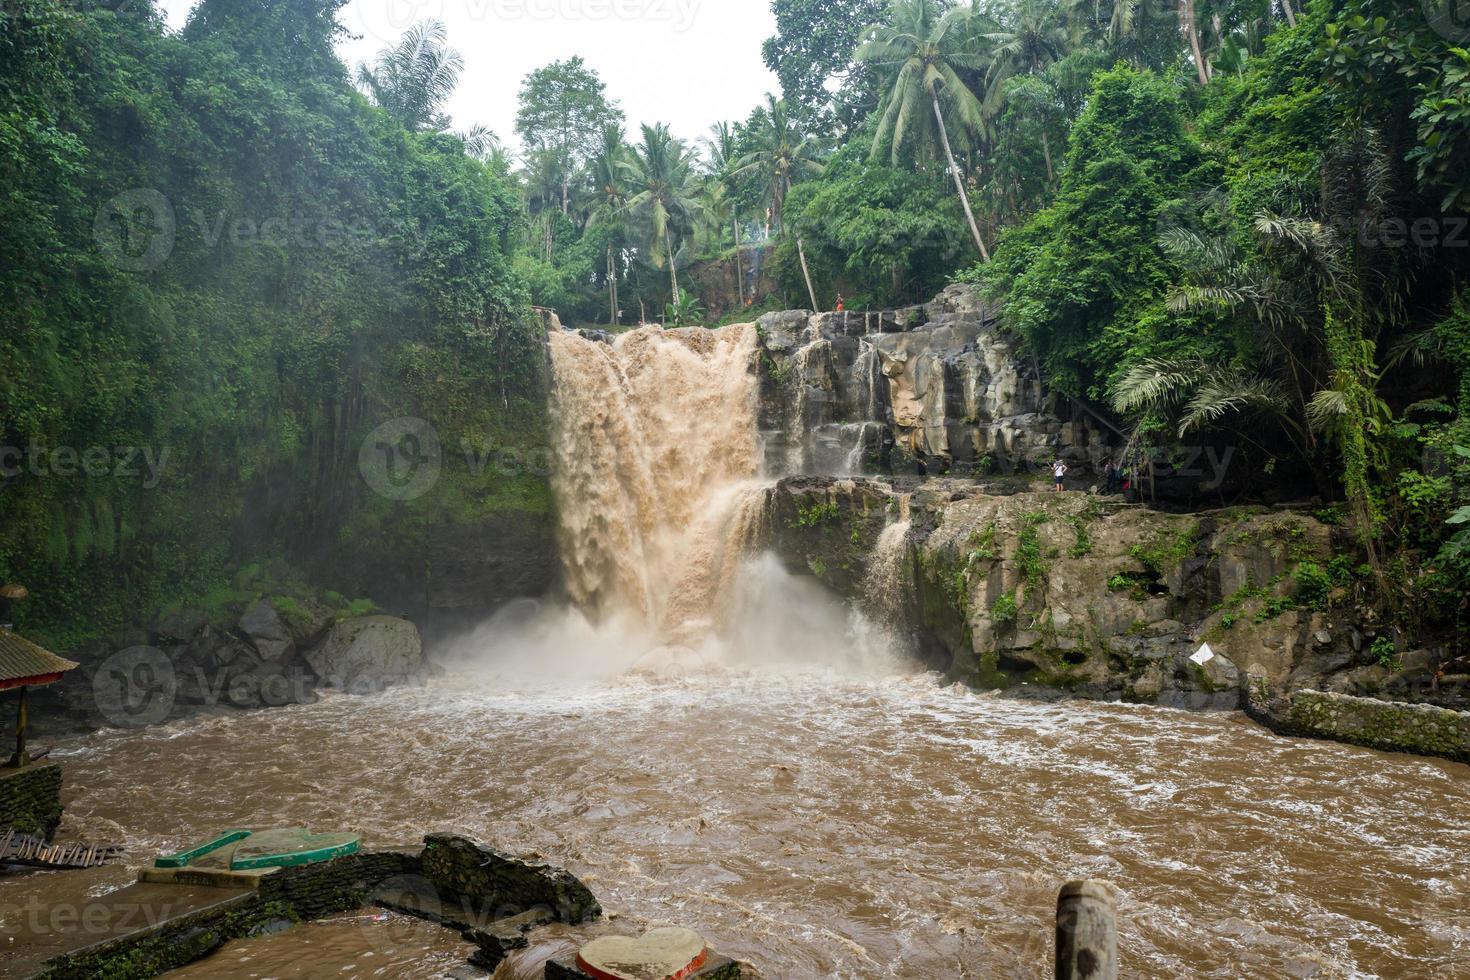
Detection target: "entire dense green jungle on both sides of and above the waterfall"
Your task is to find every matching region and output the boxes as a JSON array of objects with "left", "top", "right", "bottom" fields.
[{"left": 0, "top": 0, "right": 1470, "bottom": 658}]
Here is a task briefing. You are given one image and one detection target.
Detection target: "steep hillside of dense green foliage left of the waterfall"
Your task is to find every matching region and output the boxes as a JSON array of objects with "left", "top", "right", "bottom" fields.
[{"left": 0, "top": 0, "right": 545, "bottom": 646}]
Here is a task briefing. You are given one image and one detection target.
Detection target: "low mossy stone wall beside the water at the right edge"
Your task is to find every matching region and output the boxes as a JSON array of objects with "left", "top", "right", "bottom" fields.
[{"left": 1280, "top": 691, "right": 1470, "bottom": 763}]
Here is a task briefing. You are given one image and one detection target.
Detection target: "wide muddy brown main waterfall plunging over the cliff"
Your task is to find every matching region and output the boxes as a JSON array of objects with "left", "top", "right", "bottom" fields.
[{"left": 550, "top": 325, "right": 764, "bottom": 645}]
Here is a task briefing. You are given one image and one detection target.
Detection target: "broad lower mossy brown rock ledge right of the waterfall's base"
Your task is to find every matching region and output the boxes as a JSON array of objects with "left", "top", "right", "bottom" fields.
[{"left": 770, "top": 478, "right": 1387, "bottom": 708}]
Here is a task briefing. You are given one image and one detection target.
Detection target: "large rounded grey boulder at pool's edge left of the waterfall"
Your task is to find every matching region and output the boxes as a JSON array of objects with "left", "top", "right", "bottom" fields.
[{"left": 306, "top": 616, "right": 429, "bottom": 693}]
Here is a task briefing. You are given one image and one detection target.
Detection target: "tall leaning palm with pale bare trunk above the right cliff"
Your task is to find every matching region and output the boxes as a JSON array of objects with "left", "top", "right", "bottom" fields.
[{"left": 853, "top": 0, "right": 991, "bottom": 262}]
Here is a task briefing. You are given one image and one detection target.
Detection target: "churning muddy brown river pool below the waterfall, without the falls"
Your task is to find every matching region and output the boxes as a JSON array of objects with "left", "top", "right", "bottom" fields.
[{"left": 0, "top": 670, "right": 1470, "bottom": 977}]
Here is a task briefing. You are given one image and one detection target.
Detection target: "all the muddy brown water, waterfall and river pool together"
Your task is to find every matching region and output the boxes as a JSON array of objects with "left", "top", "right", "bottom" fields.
[{"left": 11, "top": 326, "right": 1470, "bottom": 980}]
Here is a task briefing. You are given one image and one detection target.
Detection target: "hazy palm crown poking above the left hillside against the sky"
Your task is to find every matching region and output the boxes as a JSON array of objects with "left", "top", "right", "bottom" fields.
[{"left": 357, "top": 21, "right": 465, "bottom": 132}]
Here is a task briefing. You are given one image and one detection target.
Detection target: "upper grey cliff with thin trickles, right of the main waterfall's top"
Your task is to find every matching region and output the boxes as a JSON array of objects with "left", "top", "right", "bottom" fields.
[{"left": 759, "top": 285, "right": 1104, "bottom": 476}]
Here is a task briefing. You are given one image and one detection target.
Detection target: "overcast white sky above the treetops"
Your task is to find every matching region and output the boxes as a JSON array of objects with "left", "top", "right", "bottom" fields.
[{"left": 159, "top": 0, "right": 779, "bottom": 147}]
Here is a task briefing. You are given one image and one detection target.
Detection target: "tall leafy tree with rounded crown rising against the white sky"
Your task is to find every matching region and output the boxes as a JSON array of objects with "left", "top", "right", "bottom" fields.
[{"left": 516, "top": 57, "right": 623, "bottom": 215}]
